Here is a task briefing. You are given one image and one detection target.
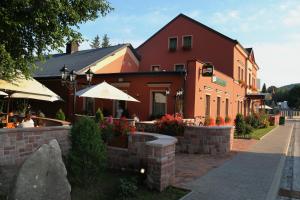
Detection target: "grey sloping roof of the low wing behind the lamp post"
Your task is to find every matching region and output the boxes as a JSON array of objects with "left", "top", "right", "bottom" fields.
[{"left": 34, "top": 44, "right": 139, "bottom": 77}]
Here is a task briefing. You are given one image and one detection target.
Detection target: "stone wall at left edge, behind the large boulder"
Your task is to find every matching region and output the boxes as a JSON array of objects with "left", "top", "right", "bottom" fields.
[{"left": 0, "top": 126, "right": 70, "bottom": 165}]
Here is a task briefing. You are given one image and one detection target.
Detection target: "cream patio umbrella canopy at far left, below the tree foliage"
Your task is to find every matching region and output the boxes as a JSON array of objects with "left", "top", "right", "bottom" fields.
[{"left": 0, "top": 78, "right": 61, "bottom": 101}]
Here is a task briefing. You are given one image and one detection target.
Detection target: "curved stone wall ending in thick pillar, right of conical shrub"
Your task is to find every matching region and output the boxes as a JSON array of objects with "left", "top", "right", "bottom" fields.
[{"left": 108, "top": 132, "right": 177, "bottom": 191}]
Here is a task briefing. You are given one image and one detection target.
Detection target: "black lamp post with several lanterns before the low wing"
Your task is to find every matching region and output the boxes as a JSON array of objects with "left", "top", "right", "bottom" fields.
[{"left": 60, "top": 65, "right": 94, "bottom": 120}]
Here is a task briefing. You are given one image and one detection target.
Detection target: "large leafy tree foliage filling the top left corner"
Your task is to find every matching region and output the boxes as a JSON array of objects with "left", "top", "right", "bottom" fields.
[{"left": 0, "top": 0, "right": 112, "bottom": 80}]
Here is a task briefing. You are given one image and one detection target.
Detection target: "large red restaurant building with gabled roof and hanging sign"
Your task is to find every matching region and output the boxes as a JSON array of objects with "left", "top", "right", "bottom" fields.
[{"left": 36, "top": 14, "right": 262, "bottom": 120}]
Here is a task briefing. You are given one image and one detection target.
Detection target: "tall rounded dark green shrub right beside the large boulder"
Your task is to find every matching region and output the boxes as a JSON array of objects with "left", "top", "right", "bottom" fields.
[{"left": 67, "top": 117, "right": 106, "bottom": 187}]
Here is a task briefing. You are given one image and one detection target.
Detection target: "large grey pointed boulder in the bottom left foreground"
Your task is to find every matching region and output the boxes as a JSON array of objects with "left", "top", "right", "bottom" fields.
[{"left": 11, "top": 140, "right": 71, "bottom": 200}]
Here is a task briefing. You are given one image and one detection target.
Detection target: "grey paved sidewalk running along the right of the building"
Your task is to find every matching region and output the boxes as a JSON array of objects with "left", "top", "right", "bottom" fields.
[{"left": 184, "top": 125, "right": 292, "bottom": 200}]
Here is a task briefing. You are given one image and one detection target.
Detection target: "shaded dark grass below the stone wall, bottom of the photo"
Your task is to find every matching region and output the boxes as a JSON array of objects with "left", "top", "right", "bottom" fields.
[{"left": 72, "top": 171, "right": 189, "bottom": 200}]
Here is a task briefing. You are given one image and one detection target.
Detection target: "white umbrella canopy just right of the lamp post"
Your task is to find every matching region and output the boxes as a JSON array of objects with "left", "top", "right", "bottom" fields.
[{"left": 76, "top": 81, "right": 140, "bottom": 102}]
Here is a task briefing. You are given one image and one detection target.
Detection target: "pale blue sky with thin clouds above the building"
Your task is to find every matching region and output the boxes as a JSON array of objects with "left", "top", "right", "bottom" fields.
[{"left": 80, "top": 0, "right": 300, "bottom": 86}]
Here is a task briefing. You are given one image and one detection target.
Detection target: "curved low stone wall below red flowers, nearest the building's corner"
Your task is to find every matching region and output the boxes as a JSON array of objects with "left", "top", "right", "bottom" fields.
[{"left": 176, "top": 126, "right": 234, "bottom": 154}]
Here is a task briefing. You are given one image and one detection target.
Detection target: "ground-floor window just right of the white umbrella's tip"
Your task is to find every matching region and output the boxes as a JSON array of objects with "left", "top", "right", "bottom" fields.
[{"left": 152, "top": 92, "right": 167, "bottom": 116}]
